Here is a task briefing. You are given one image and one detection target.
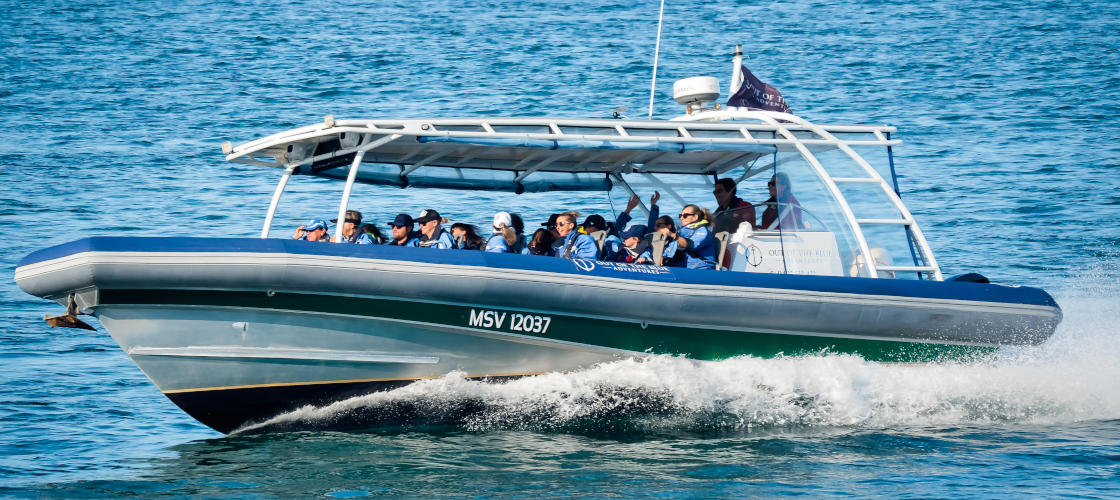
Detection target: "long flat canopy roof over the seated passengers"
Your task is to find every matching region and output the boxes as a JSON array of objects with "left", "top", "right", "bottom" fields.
[{"left": 223, "top": 112, "right": 897, "bottom": 193}]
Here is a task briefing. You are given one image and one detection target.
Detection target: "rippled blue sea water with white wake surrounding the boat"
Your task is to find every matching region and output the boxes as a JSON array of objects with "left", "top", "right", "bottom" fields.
[{"left": 0, "top": 0, "right": 1120, "bottom": 498}]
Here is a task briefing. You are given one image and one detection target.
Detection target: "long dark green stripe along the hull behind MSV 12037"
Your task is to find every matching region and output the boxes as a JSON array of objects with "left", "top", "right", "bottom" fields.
[{"left": 100, "top": 289, "right": 999, "bottom": 362}]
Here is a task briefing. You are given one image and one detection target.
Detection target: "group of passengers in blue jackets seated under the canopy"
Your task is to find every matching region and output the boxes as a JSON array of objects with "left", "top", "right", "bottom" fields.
[{"left": 292, "top": 174, "right": 801, "bottom": 269}]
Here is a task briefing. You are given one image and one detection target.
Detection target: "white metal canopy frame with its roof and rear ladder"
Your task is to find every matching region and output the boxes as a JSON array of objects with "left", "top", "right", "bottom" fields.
[{"left": 222, "top": 109, "right": 942, "bottom": 280}]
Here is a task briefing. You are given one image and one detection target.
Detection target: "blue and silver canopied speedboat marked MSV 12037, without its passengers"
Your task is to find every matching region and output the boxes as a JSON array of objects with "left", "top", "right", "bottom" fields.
[{"left": 16, "top": 54, "right": 1062, "bottom": 433}]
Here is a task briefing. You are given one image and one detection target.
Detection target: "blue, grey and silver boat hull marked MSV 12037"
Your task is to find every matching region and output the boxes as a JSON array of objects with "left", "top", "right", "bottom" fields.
[{"left": 17, "top": 238, "right": 1061, "bottom": 432}]
